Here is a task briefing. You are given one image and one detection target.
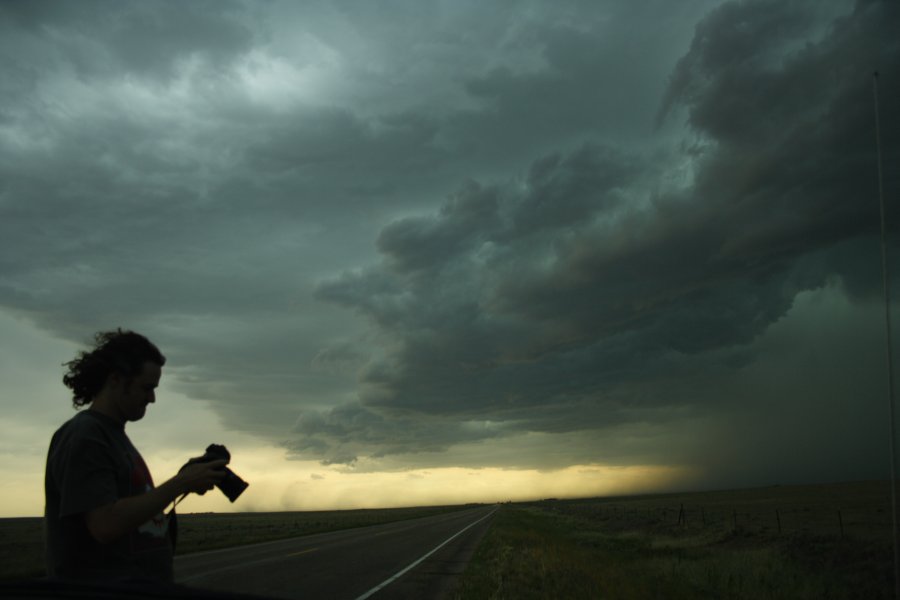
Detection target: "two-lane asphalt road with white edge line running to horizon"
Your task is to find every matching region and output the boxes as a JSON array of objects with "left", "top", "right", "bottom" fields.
[{"left": 175, "top": 506, "right": 496, "bottom": 600}]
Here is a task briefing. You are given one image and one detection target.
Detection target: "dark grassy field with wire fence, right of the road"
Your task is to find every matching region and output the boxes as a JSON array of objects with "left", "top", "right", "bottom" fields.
[{"left": 455, "top": 482, "right": 893, "bottom": 600}]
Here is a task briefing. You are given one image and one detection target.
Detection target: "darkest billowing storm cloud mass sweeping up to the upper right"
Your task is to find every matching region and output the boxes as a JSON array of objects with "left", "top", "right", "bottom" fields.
[{"left": 304, "top": 2, "right": 900, "bottom": 466}]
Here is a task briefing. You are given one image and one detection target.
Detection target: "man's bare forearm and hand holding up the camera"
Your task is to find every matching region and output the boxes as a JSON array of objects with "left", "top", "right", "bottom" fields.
[{"left": 84, "top": 460, "right": 228, "bottom": 544}]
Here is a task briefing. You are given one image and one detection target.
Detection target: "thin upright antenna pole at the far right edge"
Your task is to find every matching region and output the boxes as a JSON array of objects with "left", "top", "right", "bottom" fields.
[{"left": 872, "top": 71, "right": 900, "bottom": 600}]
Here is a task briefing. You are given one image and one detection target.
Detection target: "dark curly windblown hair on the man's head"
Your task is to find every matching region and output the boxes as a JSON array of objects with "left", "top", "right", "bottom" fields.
[{"left": 63, "top": 329, "right": 166, "bottom": 408}]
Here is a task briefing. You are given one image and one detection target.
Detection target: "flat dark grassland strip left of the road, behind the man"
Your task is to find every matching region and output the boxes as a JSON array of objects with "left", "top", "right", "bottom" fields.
[{"left": 0, "top": 506, "right": 468, "bottom": 581}]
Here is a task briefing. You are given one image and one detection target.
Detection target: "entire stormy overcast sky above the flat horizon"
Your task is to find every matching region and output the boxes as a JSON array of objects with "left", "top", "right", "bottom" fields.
[{"left": 0, "top": 0, "right": 900, "bottom": 516}]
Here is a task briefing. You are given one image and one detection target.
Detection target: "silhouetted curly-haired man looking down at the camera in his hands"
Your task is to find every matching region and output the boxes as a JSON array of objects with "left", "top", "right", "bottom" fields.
[{"left": 44, "top": 330, "right": 227, "bottom": 581}]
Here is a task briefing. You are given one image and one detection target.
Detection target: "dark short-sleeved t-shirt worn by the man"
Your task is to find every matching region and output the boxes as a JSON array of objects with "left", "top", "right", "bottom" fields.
[{"left": 44, "top": 410, "right": 172, "bottom": 581}]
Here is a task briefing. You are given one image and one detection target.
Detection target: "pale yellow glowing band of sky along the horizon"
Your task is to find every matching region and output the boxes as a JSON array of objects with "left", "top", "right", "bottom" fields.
[{"left": 0, "top": 434, "right": 691, "bottom": 517}]
